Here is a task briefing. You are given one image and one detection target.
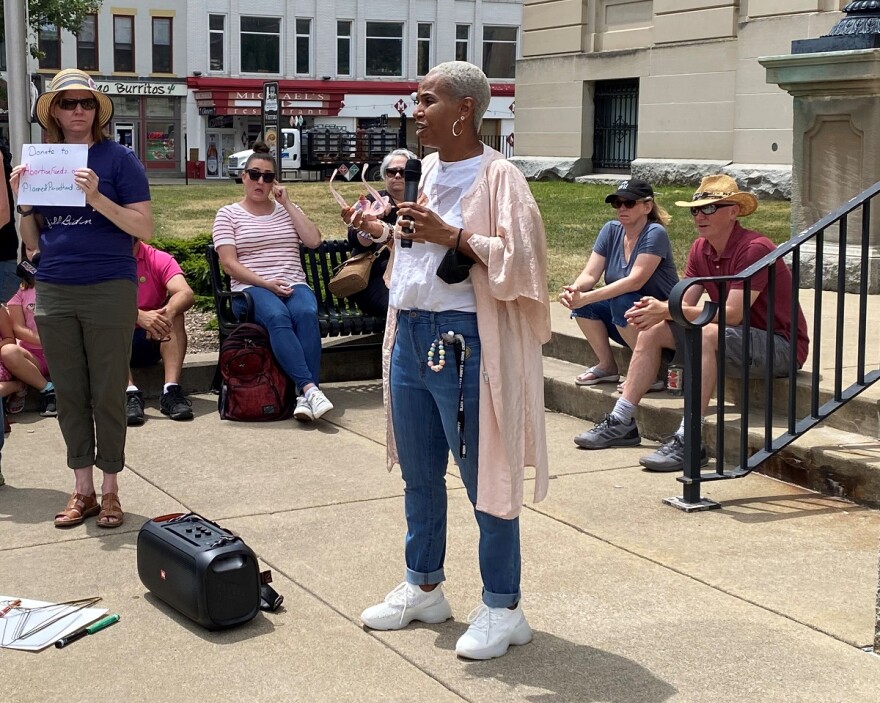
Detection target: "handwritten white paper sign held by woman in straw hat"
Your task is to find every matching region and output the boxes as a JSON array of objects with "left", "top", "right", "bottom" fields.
[{"left": 18, "top": 144, "right": 89, "bottom": 207}]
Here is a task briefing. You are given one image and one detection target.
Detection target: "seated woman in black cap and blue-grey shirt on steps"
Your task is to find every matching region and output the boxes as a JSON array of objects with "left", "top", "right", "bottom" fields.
[{"left": 559, "top": 179, "right": 678, "bottom": 389}]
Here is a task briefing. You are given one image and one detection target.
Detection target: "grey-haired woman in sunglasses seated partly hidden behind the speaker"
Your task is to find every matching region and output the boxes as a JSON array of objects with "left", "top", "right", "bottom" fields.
[{"left": 343, "top": 149, "right": 418, "bottom": 318}]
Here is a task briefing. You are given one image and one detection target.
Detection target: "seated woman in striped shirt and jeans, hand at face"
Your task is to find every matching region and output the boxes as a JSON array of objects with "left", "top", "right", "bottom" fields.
[{"left": 213, "top": 143, "right": 333, "bottom": 422}]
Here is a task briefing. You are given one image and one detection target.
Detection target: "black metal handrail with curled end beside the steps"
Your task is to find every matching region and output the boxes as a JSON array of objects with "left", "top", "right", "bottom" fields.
[{"left": 666, "top": 182, "right": 880, "bottom": 511}]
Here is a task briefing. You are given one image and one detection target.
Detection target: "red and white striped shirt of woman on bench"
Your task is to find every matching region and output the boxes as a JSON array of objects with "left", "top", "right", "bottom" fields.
[{"left": 212, "top": 203, "right": 306, "bottom": 291}]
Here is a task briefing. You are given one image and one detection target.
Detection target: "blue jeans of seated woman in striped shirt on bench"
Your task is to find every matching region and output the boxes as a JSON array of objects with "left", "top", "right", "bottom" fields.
[{"left": 232, "top": 284, "right": 321, "bottom": 390}]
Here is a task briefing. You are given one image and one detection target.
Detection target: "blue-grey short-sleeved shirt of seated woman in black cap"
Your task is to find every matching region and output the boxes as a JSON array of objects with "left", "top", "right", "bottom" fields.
[{"left": 593, "top": 220, "right": 678, "bottom": 300}]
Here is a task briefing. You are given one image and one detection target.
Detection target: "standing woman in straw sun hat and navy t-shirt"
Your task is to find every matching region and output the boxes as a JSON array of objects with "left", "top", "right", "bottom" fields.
[{"left": 10, "top": 69, "right": 153, "bottom": 527}]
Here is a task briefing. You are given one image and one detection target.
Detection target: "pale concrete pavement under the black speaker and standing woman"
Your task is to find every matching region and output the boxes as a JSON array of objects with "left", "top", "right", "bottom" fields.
[{"left": 0, "top": 383, "right": 880, "bottom": 703}]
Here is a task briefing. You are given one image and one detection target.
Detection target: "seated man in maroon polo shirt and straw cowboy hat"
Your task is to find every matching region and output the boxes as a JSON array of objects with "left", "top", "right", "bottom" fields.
[{"left": 574, "top": 175, "right": 810, "bottom": 471}]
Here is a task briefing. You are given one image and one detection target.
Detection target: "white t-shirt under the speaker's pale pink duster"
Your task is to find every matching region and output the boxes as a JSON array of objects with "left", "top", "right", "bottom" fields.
[{"left": 388, "top": 154, "right": 483, "bottom": 312}]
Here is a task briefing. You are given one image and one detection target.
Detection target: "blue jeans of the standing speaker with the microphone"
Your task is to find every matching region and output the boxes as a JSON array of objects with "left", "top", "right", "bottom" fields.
[{"left": 390, "top": 310, "right": 520, "bottom": 608}]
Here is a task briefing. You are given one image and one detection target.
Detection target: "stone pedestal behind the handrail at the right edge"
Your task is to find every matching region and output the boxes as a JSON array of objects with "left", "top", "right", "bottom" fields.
[{"left": 758, "top": 48, "right": 880, "bottom": 293}]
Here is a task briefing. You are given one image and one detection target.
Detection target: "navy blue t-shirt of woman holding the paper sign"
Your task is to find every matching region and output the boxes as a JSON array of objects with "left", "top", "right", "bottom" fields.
[{"left": 36, "top": 140, "right": 150, "bottom": 285}]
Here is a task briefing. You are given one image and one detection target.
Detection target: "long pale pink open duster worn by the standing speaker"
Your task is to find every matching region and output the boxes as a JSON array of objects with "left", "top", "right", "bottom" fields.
[{"left": 382, "top": 147, "right": 550, "bottom": 519}]
